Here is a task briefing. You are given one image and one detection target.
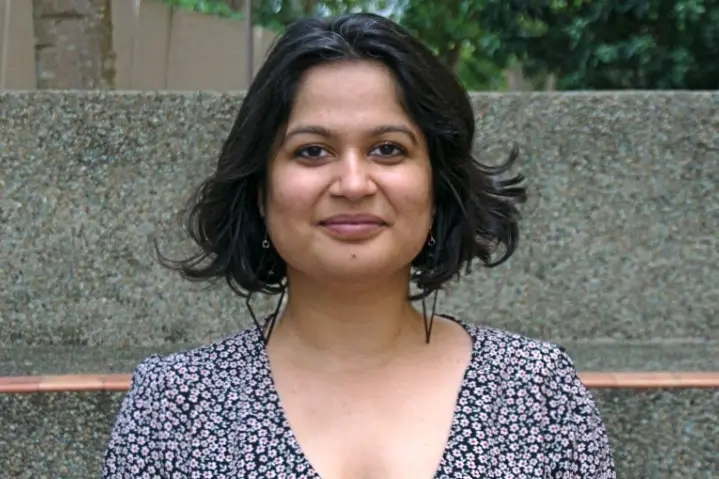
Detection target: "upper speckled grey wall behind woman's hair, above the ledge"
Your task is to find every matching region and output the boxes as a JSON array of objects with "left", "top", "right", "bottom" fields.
[{"left": 0, "top": 91, "right": 719, "bottom": 346}]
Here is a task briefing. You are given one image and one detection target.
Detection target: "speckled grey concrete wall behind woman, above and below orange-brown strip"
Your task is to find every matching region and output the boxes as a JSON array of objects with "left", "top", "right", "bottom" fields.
[{"left": 0, "top": 91, "right": 719, "bottom": 479}]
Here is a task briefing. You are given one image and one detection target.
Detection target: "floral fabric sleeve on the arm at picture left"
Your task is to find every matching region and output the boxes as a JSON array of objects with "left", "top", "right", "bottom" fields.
[{"left": 101, "top": 356, "right": 165, "bottom": 479}]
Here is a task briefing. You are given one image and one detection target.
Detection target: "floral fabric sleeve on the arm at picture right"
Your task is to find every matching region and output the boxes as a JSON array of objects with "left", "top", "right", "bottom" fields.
[{"left": 548, "top": 348, "right": 617, "bottom": 479}]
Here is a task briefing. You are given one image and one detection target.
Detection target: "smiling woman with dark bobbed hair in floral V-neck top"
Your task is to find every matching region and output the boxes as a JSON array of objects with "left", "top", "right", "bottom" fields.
[{"left": 103, "top": 14, "right": 615, "bottom": 479}]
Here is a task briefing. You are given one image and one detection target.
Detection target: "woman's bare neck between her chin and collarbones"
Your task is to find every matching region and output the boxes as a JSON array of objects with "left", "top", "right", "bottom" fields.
[{"left": 270, "top": 274, "right": 424, "bottom": 367}]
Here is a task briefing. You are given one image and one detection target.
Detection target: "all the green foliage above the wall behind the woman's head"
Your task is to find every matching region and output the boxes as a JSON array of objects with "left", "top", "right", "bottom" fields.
[{"left": 165, "top": 0, "right": 719, "bottom": 90}]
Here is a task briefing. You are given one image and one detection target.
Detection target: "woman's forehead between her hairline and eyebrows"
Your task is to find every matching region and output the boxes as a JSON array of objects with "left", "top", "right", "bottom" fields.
[{"left": 288, "top": 60, "right": 413, "bottom": 130}]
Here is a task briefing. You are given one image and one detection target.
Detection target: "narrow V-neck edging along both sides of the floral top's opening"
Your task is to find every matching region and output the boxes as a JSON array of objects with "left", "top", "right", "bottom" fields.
[{"left": 257, "top": 314, "right": 480, "bottom": 479}]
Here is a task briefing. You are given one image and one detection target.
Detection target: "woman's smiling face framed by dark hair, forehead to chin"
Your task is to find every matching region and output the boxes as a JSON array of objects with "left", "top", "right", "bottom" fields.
[{"left": 260, "top": 61, "right": 433, "bottom": 283}]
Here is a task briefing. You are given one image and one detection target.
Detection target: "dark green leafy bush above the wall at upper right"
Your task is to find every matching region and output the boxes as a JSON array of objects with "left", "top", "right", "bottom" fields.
[{"left": 472, "top": 0, "right": 719, "bottom": 89}]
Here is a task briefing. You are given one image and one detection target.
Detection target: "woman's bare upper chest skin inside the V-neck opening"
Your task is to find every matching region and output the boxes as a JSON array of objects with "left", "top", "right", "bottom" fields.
[{"left": 277, "top": 364, "right": 464, "bottom": 479}]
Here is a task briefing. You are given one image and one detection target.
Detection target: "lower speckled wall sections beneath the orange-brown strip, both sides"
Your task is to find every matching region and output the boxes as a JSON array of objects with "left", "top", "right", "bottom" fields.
[{"left": 0, "top": 389, "right": 719, "bottom": 479}]
